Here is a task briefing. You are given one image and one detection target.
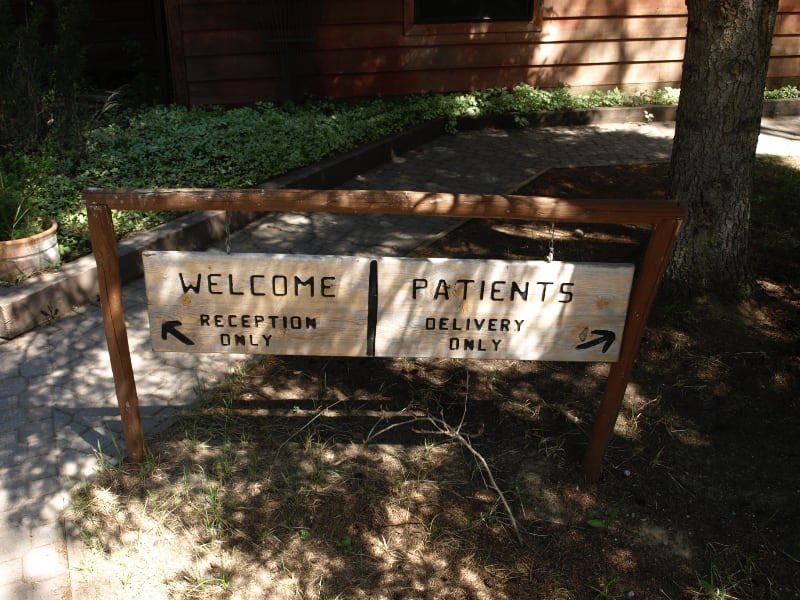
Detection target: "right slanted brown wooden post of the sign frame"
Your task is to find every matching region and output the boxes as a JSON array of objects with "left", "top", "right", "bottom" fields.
[{"left": 583, "top": 219, "right": 681, "bottom": 483}]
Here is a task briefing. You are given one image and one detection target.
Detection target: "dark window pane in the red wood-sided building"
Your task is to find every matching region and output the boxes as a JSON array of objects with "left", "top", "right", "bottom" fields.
[{"left": 414, "top": 0, "right": 533, "bottom": 23}]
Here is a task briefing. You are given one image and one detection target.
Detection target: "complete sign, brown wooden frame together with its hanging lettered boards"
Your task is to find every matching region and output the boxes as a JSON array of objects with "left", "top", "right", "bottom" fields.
[{"left": 83, "top": 189, "right": 686, "bottom": 481}]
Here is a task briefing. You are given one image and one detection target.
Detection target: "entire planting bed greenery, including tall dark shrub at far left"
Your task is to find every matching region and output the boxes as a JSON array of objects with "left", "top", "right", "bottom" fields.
[{"left": 0, "top": 0, "right": 800, "bottom": 260}]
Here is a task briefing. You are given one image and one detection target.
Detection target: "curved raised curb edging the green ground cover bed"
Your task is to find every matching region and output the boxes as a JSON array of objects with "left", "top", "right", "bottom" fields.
[{"left": 0, "top": 99, "right": 800, "bottom": 343}]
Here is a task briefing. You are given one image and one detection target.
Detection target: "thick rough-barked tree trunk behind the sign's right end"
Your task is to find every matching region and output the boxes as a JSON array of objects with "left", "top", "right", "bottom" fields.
[{"left": 665, "top": 0, "right": 778, "bottom": 299}]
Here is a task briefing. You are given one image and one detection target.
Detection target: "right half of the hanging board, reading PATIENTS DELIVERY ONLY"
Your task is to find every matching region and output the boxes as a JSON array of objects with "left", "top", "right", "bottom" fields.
[{"left": 375, "top": 258, "right": 634, "bottom": 362}]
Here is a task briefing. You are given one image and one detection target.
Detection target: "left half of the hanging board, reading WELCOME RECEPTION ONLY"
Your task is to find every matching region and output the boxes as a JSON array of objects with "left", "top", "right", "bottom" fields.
[{"left": 142, "top": 252, "right": 370, "bottom": 356}]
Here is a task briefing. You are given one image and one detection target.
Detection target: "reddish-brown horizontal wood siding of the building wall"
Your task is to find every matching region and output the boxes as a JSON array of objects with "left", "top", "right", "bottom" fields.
[{"left": 165, "top": 0, "right": 800, "bottom": 104}]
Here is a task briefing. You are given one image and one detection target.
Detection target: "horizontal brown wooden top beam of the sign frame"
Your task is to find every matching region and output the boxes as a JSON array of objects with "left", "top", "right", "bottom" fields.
[{"left": 83, "top": 188, "right": 686, "bottom": 224}]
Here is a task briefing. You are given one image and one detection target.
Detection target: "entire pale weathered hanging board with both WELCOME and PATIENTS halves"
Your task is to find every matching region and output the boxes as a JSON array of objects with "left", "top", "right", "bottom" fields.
[{"left": 142, "top": 252, "right": 634, "bottom": 362}]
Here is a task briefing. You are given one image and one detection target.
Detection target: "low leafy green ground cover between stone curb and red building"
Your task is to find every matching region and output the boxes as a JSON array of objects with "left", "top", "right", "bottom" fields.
[{"left": 0, "top": 79, "right": 797, "bottom": 260}]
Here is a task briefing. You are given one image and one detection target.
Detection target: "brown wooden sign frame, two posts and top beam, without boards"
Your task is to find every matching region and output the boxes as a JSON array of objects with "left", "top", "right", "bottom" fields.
[{"left": 83, "top": 188, "right": 686, "bottom": 482}]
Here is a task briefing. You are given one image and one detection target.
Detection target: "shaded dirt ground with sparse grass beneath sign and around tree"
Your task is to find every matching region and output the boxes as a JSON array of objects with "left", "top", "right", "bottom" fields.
[{"left": 71, "top": 165, "right": 800, "bottom": 600}]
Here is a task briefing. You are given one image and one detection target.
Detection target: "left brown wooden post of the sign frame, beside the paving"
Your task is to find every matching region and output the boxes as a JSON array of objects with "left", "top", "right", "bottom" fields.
[{"left": 87, "top": 204, "right": 144, "bottom": 463}]
